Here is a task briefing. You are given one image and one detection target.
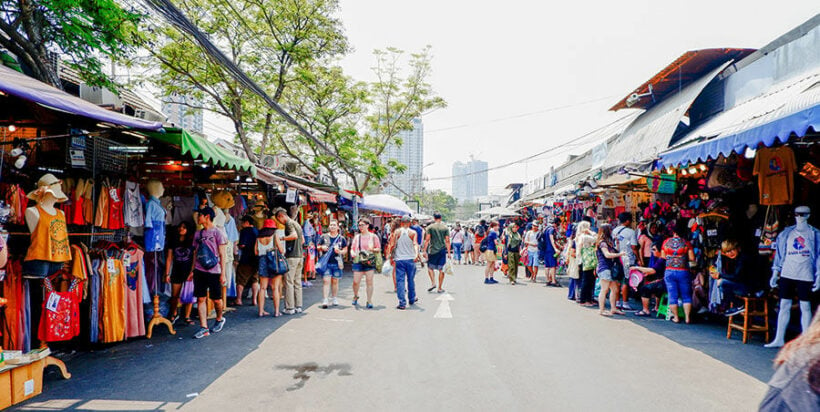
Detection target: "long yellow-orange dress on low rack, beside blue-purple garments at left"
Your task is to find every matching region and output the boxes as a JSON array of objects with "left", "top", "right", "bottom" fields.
[{"left": 100, "top": 257, "right": 126, "bottom": 343}]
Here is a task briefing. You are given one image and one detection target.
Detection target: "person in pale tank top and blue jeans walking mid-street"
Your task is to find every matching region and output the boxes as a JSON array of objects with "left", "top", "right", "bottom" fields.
[{"left": 387, "top": 216, "right": 419, "bottom": 310}]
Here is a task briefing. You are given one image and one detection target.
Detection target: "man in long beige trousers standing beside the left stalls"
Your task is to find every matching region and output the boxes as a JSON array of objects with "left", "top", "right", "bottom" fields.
[{"left": 274, "top": 207, "right": 305, "bottom": 315}]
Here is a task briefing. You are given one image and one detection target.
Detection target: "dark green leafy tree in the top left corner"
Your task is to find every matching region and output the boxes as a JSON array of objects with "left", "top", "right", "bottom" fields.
[{"left": 0, "top": 0, "right": 140, "bottom": 89}]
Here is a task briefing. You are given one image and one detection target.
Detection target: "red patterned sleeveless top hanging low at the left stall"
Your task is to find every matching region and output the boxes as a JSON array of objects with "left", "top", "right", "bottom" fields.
[{"left": 38, "top": 272, "right": 80, "bottom": 342}]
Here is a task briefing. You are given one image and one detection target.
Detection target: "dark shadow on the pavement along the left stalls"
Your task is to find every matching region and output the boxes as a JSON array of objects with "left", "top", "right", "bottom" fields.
[{"left": 15, "top": 273, "right": 352, "bottom": 410}]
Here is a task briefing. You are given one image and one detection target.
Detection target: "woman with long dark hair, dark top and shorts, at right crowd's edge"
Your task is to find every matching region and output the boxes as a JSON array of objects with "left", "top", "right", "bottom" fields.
[{"left": 596, "top": 223, "right": 624, "bottom": 316}]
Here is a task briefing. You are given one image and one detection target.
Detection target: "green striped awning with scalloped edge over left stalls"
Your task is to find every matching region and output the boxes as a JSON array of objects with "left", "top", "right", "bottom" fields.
[{"left": 145, "top": 127, "right": 256, "bottom": 176}]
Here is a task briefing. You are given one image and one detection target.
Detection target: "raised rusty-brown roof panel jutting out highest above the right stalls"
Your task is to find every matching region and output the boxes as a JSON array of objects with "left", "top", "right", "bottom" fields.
[{"left": 609, "top": 48, "right": 755, "bottom": 111}]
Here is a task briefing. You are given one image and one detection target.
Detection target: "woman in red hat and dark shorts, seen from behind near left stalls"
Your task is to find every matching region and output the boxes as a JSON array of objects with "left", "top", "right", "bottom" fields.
[{"left": 254, "top": 219, "right": 285, "bottom": 318}]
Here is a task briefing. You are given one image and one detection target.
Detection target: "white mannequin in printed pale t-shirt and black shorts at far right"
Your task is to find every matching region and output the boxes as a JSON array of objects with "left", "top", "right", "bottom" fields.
[{"left": 765, "top": 206, "right": 820, "bottom": 348}]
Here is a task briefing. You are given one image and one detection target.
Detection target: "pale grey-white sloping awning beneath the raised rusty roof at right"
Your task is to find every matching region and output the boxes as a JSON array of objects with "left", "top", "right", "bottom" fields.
[{"left": 603, "top": 61, "right": 731, "bottom": 173}]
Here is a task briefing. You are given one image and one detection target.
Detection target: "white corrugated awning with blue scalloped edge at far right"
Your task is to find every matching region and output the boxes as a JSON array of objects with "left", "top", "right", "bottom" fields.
[{"left": 659, "top": 70, "right": 820, "bottom": 167}]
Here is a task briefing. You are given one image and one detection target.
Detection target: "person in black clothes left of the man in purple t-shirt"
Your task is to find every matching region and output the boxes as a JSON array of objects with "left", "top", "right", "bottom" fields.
[{"left": 165, "top": 222, "right": 195, "bottom": 325}]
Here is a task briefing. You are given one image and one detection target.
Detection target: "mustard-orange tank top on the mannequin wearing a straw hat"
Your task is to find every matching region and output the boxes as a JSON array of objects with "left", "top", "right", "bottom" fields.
[{"left": 25, "top": 205, "right": 71, "bottom": 262}]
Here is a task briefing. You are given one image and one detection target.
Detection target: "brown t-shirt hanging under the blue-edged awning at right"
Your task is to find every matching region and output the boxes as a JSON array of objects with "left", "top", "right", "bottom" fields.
[{"left": 754, "top": 147, "right": 797, "bottom": 205}]
